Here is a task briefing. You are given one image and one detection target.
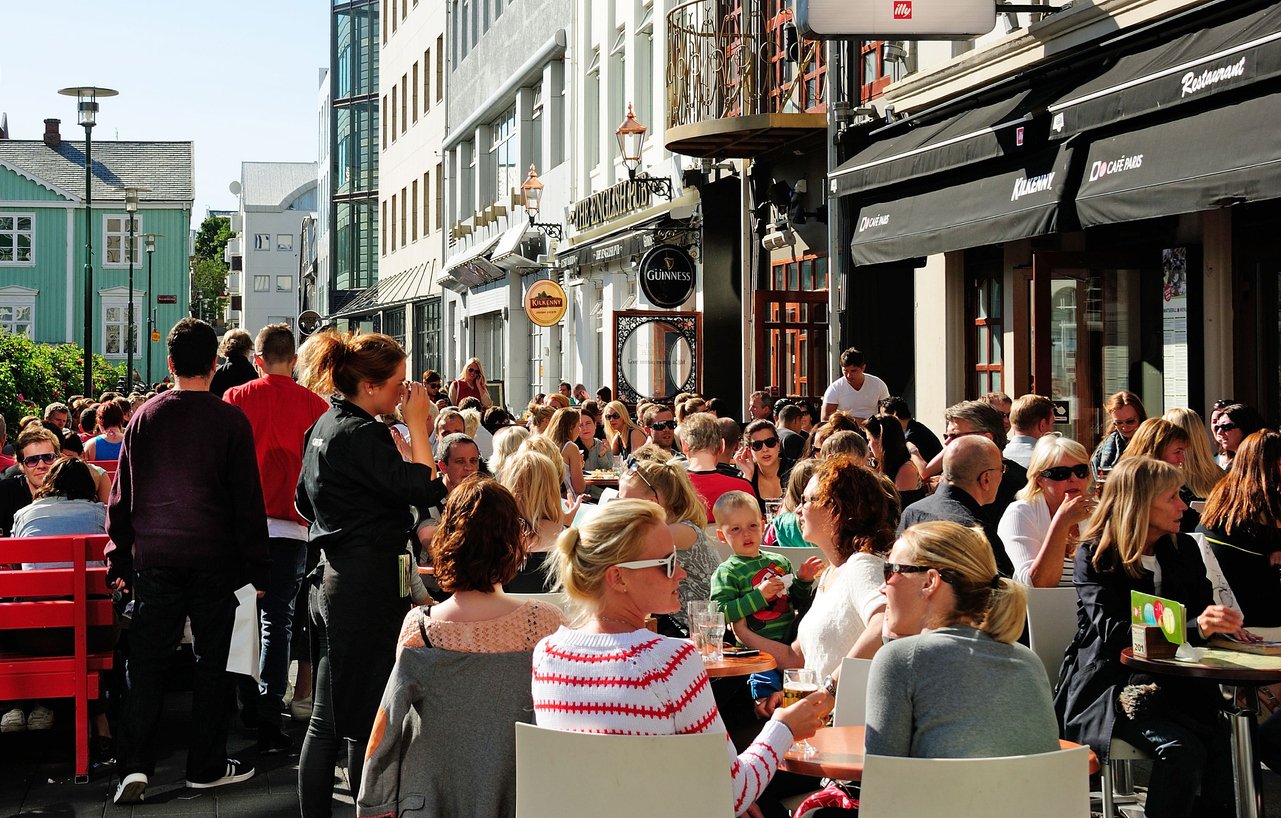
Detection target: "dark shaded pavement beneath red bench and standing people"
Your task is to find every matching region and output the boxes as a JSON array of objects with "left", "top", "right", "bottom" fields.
[{"left": 0, "top": 693, "right": 352, "bottom": 818}]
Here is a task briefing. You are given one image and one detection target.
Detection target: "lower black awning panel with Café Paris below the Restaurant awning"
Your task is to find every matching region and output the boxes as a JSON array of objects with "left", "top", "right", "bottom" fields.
[{"left": 1076, "top": 88, "right": 1281, "bottom": 227}]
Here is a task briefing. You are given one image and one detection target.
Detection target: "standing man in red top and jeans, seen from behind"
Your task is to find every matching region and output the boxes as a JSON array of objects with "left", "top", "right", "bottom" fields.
[{"left": 223, "top": 324, "right": 329, "bottom": 753}]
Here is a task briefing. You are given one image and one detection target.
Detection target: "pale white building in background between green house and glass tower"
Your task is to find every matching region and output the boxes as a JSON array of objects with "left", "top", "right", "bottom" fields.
[{"left": 232, "top": 161, "right": 316, "bottom": 335}]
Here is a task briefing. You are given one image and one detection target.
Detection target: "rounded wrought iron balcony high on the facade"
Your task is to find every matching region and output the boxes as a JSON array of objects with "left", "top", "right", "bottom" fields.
[{"left": 666, "top": 0, "right": 826, "bottom": 159}]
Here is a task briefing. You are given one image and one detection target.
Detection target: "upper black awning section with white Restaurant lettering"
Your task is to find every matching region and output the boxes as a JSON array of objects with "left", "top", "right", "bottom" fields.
[{"left": 1049, "top": 4, "right": 1281, "bottom": 138}]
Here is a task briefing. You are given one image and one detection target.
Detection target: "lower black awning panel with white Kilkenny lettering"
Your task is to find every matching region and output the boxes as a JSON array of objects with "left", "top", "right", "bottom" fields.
[{"left": 849, "top": 146, "right": 1072, "bottom": 265}]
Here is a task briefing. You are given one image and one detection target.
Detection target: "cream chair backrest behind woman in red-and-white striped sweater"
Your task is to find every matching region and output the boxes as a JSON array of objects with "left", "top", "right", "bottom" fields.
[{"left": 516, "top": 725, "right": 734, "bottom": 818}]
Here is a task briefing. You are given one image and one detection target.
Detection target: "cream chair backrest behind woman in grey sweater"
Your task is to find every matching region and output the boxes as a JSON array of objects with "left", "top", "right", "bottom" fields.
[{"left": 858, "top": 746, "right": 1090, "bottom": 818}]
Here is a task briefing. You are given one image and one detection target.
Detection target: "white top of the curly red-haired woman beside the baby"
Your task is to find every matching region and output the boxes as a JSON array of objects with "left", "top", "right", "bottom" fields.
[{"left": 797, "top": 554, "right": 885, "bottom": 678}]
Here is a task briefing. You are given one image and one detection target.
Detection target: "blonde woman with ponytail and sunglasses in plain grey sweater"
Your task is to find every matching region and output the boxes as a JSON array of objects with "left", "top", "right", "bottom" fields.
[{"left": 866, "top": 521, "right": 1058, "bottom": 758}]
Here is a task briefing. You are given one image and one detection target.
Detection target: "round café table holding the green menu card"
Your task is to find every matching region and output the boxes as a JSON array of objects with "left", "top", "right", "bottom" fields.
[{"left": 1121, "top": 648, "right": 1281, "bottom": 818}]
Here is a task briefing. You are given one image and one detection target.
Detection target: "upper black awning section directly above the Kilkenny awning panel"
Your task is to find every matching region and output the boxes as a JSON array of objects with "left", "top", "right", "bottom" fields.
[{"left": 828, "top": 82, "right": 1063, "bottom": 196}]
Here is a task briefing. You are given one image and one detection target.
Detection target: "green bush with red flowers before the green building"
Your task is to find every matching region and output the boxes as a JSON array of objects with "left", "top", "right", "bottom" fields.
[{"left": 0, "top": 330, "right": 124, "bottom": 429}]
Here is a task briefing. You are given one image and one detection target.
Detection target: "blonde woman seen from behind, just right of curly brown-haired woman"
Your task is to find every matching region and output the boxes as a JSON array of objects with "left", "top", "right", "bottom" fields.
[{"left": 498, "top": 449, "right": 565, "bottom": 594}]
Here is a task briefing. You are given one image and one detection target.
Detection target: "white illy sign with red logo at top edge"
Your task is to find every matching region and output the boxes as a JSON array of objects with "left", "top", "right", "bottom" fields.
[{"left": 796, "top": 0, "right": 997, "bottom": 40}]
